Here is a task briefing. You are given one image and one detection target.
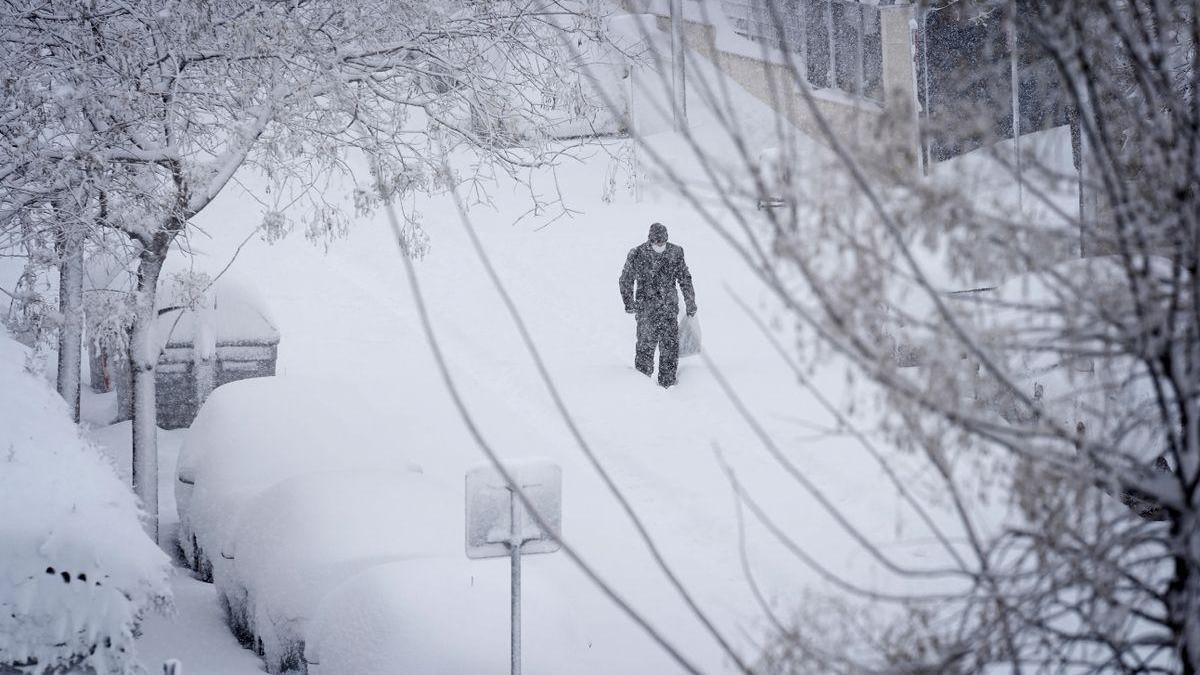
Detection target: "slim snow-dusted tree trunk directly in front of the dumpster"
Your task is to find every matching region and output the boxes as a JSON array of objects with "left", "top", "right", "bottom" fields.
[{"left": 130, "top": 249, "right": 166, "bottom": 542}]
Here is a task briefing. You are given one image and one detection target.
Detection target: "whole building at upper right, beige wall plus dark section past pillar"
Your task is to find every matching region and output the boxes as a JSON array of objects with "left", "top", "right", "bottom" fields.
[{"left": 623, "top": 0, "right": 1078, "bottom": 167}]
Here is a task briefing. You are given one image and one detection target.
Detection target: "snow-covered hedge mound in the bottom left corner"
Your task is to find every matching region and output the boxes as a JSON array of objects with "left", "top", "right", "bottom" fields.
[{"left": 0, "top": 331, "right": 170, "bottom": 674}]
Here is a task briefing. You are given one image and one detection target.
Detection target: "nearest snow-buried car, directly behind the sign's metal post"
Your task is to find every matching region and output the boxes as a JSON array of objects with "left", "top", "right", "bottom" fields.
[{"left": 304, "top": 555, "right": 580, "bottom": 675}]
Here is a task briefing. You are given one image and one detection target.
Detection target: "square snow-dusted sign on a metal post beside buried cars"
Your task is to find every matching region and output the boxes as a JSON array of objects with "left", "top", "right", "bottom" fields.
[{"left": 467, "top": 460, "right": 563, "bottom": 675}]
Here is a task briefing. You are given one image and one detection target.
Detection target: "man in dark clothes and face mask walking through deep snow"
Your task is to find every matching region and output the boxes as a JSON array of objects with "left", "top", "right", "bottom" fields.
[{"left": 620, "top": 222, "right": 696, "bottom": 387}]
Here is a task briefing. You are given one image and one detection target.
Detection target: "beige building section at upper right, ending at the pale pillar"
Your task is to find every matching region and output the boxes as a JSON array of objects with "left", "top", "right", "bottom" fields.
[{"left": 623, "top": 0, "right": 919, "bottom": 167}]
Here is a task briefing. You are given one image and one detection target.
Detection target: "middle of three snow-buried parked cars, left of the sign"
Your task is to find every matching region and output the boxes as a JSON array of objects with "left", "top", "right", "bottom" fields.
[{"left": 215, "top": 468, "right": 462, "bottom": 671}]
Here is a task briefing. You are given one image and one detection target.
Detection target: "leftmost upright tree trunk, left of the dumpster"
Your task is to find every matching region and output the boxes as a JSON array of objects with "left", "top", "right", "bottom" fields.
[{"left": 56, "top": 228, "right": 83, "bottom": 423}]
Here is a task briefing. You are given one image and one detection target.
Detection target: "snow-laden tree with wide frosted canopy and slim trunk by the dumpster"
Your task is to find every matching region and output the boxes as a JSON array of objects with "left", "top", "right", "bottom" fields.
[{"left": 0, "top": 0, "right": 596, "bottom": 538}]
